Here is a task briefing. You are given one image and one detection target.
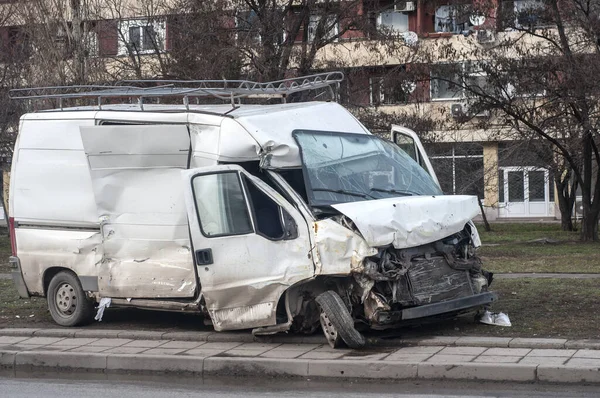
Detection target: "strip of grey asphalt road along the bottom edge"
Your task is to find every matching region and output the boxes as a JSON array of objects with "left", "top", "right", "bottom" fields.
[{"left": 0, "top": 374, "right": 600, "bottom": 398}]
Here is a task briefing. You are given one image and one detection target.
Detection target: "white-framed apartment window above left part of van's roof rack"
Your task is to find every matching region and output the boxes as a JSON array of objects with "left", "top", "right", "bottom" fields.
[{"left": 119, "top": 19, "right": 166, "bottom": 55}]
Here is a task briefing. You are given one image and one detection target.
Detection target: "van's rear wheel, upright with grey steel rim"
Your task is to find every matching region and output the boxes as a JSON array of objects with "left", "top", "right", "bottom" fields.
[{"left": 46, "top": 271, "right": 94, "bottom": 326}]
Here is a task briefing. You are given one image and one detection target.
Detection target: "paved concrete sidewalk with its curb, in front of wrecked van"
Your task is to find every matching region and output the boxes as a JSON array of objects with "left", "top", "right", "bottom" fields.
[{"left": 0, "top": 329, "right": 600, "bottom": 383}]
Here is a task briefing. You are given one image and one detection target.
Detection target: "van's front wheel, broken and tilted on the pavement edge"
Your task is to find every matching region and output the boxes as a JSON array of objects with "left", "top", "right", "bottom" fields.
[{"left": 316, "top": 290, "right": 365, "bottom": 348}]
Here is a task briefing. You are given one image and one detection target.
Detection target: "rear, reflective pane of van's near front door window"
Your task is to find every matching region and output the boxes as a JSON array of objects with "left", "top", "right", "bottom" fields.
[{"left": 192, "top": 172, "right": 254, "bottom": 237}]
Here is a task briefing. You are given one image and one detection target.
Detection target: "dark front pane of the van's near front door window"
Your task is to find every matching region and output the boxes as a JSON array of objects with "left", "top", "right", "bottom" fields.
[{"left": 243, "top": 177, "right": 284, "bottom": 240}]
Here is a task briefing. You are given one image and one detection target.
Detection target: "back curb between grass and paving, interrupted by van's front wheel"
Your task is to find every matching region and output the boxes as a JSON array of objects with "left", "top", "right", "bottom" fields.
[{"left": 0, "top": 328, "right": 600, "bottom": 350}]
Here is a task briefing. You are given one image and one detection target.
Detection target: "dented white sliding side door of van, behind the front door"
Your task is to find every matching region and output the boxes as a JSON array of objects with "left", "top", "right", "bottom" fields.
[{"left": 80, "top": 125, "right": 197, "bottom": 298}]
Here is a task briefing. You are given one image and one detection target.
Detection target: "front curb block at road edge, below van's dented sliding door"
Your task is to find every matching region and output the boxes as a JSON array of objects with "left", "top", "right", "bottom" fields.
[{"left": 106, "top": 355, "right": 204, "bottom": 374}]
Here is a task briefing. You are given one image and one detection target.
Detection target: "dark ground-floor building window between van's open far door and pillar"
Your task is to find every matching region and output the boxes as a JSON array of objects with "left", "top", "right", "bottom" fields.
[{"left": 425, "top": 142, "right": 484, "bottom": 198}]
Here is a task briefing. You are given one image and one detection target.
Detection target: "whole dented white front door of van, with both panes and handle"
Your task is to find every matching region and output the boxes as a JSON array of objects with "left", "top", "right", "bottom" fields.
[{"left": 183, "top": 165, "right": 315, "bottom": 330}]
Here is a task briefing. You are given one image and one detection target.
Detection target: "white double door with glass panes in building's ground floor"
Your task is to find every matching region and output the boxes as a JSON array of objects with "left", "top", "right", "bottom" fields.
[{"left": 499, "top": 167, "right": 554, "bottom": 217}]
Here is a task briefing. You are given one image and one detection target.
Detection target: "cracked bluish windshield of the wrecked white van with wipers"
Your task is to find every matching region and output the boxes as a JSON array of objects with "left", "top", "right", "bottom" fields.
[{"left": 293, "top": 130, "right": 442, "bottom": 206}]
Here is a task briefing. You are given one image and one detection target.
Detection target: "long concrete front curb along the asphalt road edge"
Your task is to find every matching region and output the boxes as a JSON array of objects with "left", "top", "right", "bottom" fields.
[{"left": 0, "top": 351, "right": 600, "bottom": 383}]
